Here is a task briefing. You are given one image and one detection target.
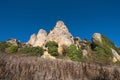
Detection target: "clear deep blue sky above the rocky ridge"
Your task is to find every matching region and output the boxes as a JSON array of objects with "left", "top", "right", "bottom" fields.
[{"left": 0, "top": 0, "right": 120, "bottom": 46}]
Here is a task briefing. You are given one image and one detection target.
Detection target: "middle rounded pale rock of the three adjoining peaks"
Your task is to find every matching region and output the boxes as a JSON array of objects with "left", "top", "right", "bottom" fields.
[{"left": 33, "top": 29, "right": 47, "bottom": 47}]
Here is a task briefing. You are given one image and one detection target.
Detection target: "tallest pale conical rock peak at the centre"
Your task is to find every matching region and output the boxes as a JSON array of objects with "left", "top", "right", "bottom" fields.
[{"left": 47, "top": 21, "right": 74, "bottom": 53}]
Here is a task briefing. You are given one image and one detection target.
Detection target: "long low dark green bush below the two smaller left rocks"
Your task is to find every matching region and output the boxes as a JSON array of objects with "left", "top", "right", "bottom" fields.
[{"left": 19, "top": 47, "right": 44, "bottom": 56}]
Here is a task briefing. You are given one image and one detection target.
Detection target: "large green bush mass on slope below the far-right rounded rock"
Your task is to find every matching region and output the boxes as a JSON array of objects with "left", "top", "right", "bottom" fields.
[{"left": 92, "top": 35, "right": 116, "bottom": 64}]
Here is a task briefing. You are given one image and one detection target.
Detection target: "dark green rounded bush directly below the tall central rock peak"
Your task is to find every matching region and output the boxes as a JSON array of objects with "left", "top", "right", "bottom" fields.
[{"left": 45, "top": 41, "right": 59, "bottom": 56}]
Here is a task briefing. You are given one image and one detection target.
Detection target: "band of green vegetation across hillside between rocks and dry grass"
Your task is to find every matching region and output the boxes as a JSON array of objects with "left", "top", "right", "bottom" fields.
[{"left": 0, "top": 35, "right": 120, "bottom": 64}]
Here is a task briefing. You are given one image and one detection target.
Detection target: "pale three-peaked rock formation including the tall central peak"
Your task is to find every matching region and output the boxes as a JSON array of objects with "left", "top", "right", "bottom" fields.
[{"left": 27, "top": 21, "right": 74, "bottom": 54}]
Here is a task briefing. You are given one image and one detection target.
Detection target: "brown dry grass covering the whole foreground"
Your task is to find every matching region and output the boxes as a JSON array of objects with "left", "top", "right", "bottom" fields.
[{"left": 0, "top": 54, "right": 120, "bottom": 80}]
